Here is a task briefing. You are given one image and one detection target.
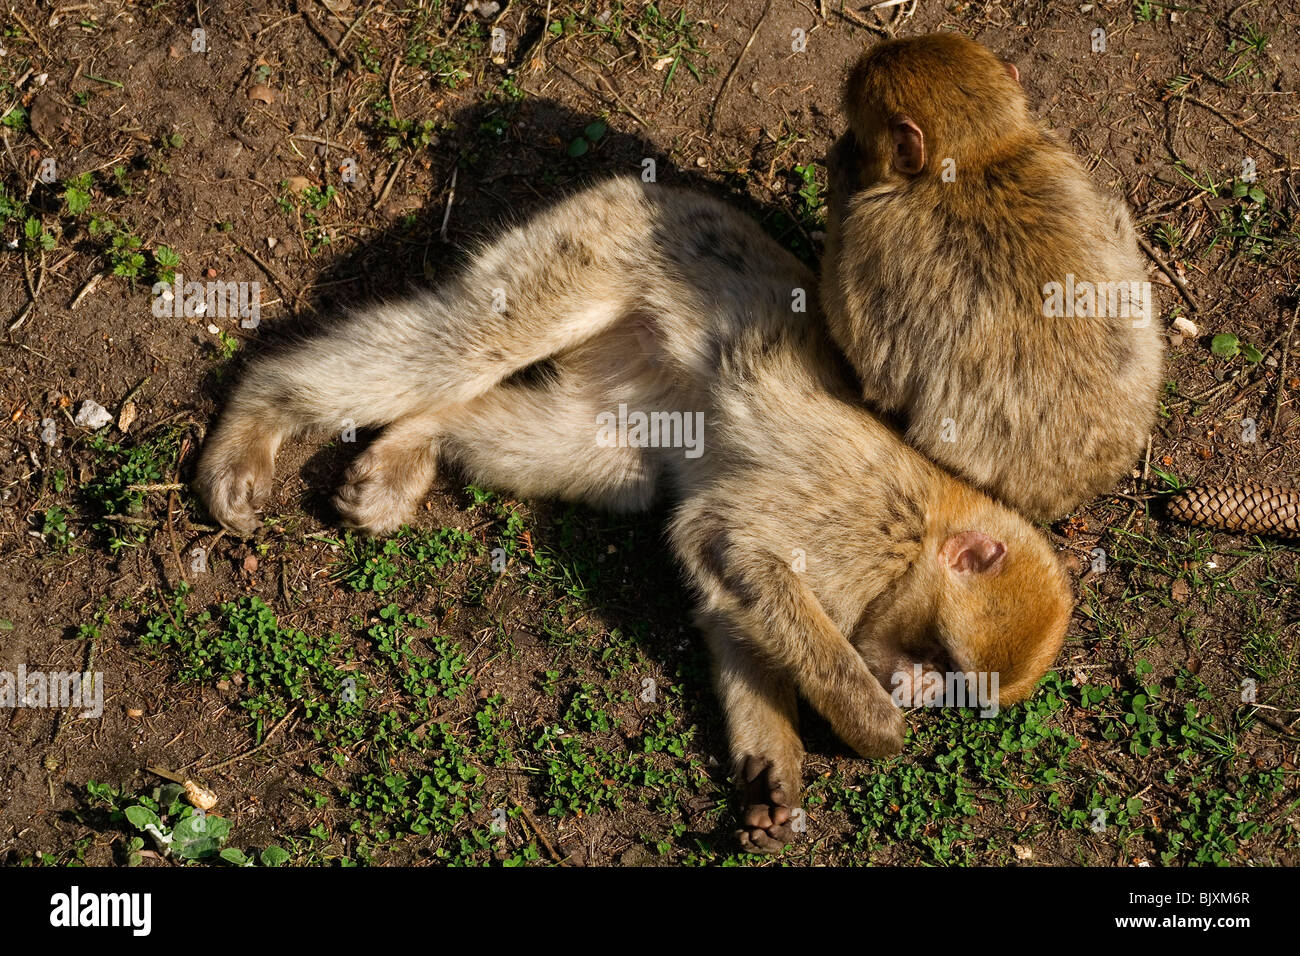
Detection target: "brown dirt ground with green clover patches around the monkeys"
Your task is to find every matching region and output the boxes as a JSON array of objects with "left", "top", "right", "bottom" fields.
[{"left": 0, "top": 0, "right": 1300, "bottom": 866}]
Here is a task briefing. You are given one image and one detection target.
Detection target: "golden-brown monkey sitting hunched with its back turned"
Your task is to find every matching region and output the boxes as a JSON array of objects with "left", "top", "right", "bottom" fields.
[{"left": 822, "top": 34, "right": 1162, "bottom": 520}]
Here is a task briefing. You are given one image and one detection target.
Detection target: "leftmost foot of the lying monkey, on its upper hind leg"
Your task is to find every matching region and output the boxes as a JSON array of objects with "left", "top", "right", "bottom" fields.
[{"left": 194, "top": 427, "right": 274, "bottom": 536}]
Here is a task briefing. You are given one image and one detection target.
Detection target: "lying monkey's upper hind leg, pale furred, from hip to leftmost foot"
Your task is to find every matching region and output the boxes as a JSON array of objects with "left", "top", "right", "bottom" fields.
[{"left": 195, "top": 178, "right": 657, "bottom": 533}]
